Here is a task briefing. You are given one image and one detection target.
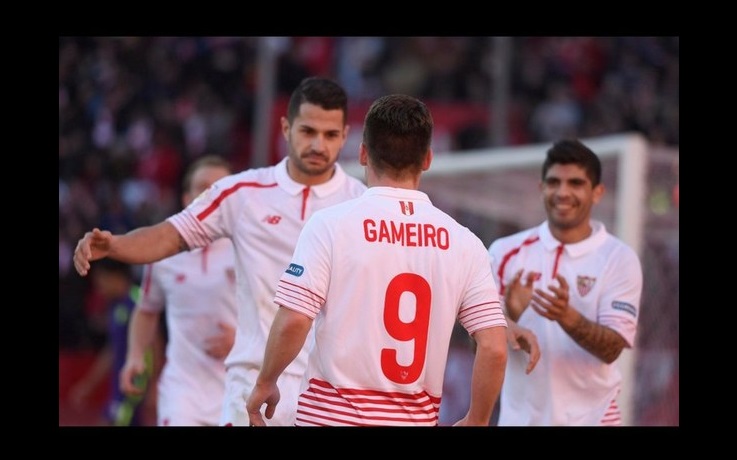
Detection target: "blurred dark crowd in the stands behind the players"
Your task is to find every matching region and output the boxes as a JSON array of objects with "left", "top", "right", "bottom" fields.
[{"left": 59, "top": 37, "right": 679, "bottom": 349}]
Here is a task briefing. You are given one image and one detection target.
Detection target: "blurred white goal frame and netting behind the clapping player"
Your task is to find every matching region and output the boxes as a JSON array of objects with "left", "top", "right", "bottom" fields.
[{"left": 341, "top": 133, "right": 648, "bottom": 425}]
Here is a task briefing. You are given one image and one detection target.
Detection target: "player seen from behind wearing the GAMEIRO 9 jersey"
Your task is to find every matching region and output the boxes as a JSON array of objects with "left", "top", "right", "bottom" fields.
[{"left": 247, "top": 95, "right": 507, "bottom": 426}]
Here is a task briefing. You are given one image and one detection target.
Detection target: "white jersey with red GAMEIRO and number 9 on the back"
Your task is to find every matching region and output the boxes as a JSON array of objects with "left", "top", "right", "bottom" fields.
[{"left": 274, "top": 187, "right": 506, "bottom": 426}]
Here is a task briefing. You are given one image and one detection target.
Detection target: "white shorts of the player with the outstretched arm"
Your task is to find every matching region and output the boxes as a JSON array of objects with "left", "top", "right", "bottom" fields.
[{"left": 220, "top": 365, "right": 302, "bottom": 426}]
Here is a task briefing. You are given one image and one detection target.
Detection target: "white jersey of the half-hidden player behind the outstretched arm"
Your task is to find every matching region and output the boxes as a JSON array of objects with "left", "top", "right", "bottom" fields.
[{"left": 137, "top": 238, "right": 236, "bottom": 425}]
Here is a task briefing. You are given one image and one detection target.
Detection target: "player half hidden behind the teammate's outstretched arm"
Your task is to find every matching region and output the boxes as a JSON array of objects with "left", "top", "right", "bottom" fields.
[{"left": 120, "top": 156, "right": 237, "bottom": 426}]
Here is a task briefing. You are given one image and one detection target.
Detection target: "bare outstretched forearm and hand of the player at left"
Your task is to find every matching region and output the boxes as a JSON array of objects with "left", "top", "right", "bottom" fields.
[{"left": 74, "top": 221, "right": 188, "bottom": 276}]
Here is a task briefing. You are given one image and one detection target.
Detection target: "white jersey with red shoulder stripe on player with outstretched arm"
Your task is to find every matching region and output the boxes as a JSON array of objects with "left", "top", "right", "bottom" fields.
[{"left": 169, "top": 158, "right": 366, "bottom": 375}]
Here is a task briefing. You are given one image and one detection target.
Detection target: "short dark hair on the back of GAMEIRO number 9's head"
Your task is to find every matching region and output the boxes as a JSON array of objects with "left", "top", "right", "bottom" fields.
[{"left": 363, "top": 94, "right": 433, "bottom": 175}]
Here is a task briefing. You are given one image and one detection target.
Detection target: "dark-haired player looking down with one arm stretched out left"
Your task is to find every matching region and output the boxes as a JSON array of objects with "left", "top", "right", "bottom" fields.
[{"left": 74, "top": 77, "right": 366, "bottom": 426}]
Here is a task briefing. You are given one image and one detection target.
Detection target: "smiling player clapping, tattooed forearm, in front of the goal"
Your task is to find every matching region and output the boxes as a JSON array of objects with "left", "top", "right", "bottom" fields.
[{"left": 489, "top": 140, "right": 642, "bottom": 426}]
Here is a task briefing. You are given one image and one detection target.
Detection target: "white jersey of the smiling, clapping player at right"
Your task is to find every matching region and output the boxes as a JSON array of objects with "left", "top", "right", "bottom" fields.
[{"left": 489, "top": 221, "right": 642, "bottom": 426}]
